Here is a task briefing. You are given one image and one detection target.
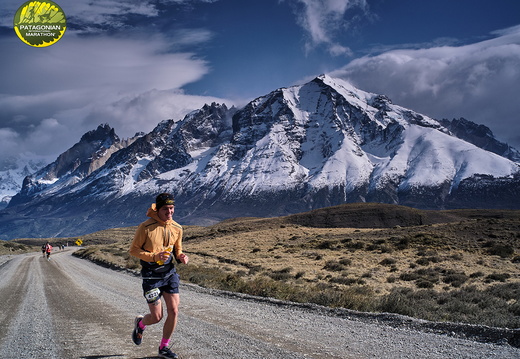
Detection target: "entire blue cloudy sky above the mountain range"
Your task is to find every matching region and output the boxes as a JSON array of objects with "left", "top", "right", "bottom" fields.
[{"left": 0, "top": 0, "right": 520, "bottom": 170}]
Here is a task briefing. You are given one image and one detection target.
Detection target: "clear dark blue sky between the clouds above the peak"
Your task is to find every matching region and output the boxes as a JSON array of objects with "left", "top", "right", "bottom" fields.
[{"left": 184, "top": 0, "right": 520, "bottom": 98}]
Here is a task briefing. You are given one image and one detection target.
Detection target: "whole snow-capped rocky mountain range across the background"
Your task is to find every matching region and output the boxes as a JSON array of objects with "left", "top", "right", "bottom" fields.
[{"left": 0, "top": 75, "right": 520, "bottom": 238}]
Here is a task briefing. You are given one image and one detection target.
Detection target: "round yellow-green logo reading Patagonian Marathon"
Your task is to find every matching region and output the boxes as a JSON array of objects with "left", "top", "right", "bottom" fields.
[{"left": 14, "top": 1, "right": 67, "bottom": 47}]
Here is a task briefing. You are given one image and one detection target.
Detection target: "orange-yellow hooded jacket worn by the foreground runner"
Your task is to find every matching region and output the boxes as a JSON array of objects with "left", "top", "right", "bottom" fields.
[{"left": 129, "top": 203, "right": 182, "bottom": 262}]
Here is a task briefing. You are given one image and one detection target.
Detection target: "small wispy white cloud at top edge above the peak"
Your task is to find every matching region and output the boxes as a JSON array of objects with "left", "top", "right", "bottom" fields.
[{"left": 286, "top": 0, "right": 368, "bottom": 56}]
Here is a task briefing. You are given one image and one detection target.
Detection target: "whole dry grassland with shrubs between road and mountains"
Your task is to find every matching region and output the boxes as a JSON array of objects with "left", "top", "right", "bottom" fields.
[{"left": 8, "top": 206, "right": 520, "bottom": 328}]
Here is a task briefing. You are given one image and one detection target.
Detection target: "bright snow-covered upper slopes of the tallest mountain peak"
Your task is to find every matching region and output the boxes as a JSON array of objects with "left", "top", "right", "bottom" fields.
[{"left": 221, "top": 76, "right": 518, "bottom": 200}]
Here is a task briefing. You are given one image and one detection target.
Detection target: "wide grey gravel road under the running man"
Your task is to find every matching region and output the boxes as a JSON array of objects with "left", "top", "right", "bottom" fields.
[{"left": 0, "top": 251, "right": 520, "bottom": 359}]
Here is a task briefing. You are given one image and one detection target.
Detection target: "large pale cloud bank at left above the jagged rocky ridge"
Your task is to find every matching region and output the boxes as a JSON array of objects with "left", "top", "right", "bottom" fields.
[{"left": 0, "top": 0, "right": 231, "bottom": 169}]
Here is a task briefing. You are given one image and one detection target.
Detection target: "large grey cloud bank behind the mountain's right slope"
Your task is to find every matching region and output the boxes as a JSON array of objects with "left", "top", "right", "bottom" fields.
[{"left": 331, "top": 26, "right": 520, "bottom": 148}]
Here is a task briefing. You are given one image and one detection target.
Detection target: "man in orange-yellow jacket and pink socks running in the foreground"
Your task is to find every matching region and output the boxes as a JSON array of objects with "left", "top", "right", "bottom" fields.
[{"left": 130, "top": 193, "right": 189, "bottom": 359}]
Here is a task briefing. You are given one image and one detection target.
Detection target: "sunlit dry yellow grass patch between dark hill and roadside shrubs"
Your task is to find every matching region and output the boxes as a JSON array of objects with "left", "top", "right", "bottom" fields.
[{"left": 185, "top": 219, "right": 520, "bottom": 295}]
